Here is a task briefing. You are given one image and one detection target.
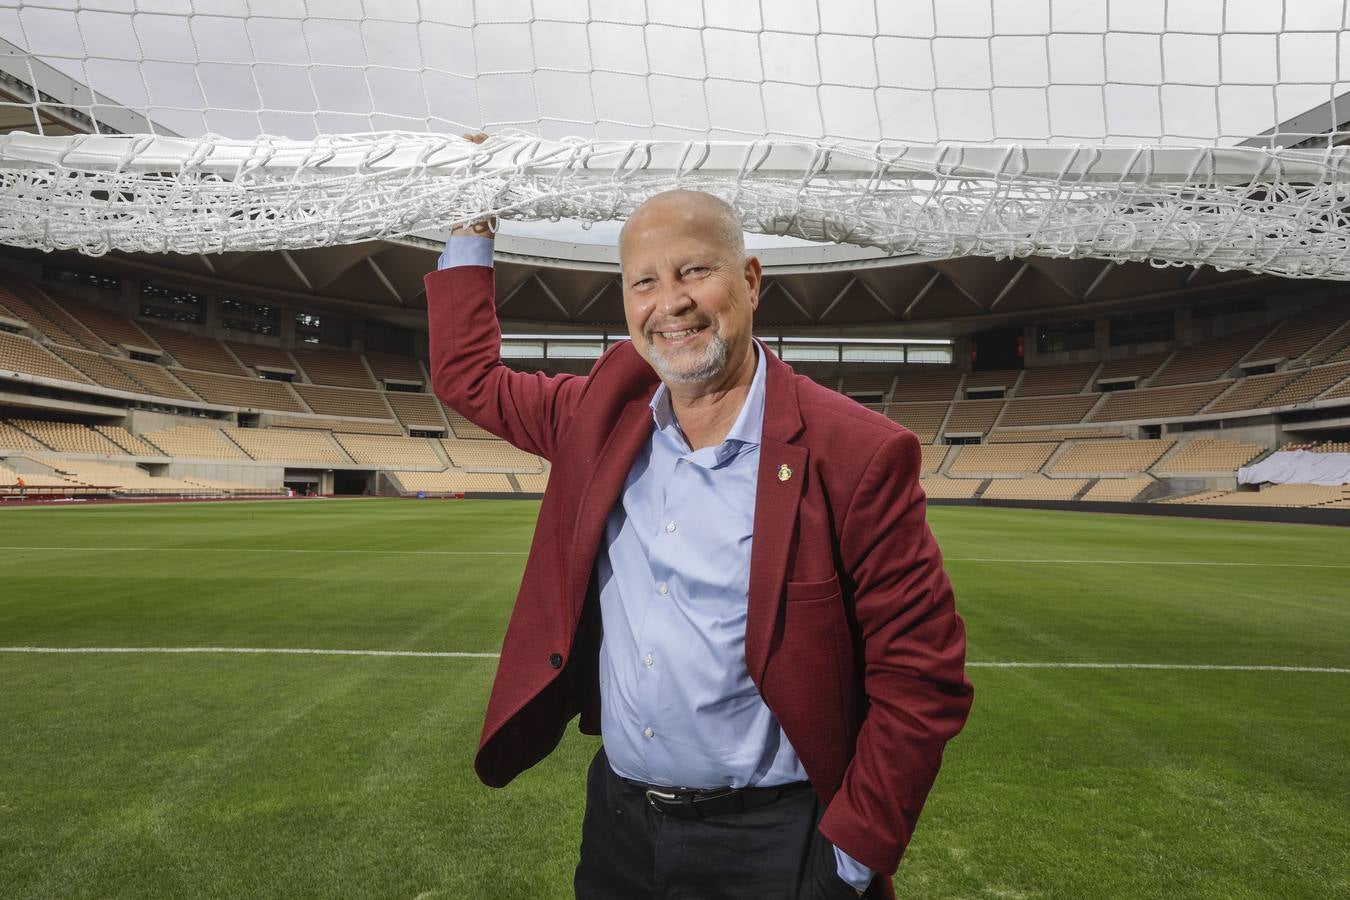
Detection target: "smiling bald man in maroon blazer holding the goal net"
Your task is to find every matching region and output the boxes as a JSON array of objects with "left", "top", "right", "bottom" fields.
[{"left": 427, "top": 192, "right": 972, "bottom": 900}]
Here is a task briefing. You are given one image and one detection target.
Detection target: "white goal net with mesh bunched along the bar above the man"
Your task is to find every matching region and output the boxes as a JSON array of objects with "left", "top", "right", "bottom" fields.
[{"left": 0, "top": 0, "right": 1350, "bottom": 278}]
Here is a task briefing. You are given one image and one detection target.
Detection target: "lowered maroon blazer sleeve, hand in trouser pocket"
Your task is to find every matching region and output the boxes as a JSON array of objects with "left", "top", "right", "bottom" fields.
[{"left": 819, "top": 432, "right": 973, "bottom": 874}]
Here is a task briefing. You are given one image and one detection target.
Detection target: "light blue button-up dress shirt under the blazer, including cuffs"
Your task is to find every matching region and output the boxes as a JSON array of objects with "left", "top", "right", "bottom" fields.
[{"left": 440, "top": 236, "right": 872, "bottom": 891}]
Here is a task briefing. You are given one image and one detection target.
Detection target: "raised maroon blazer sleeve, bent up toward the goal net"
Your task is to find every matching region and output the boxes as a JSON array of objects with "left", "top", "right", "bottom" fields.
[{"left": 424, "top": 266, "right": 586, "bottom": 460}]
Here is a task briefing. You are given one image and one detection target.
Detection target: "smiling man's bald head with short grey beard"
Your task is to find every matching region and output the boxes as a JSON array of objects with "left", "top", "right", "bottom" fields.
[{"left": 620, "top": 201, "right": 760, "bottom": 387}]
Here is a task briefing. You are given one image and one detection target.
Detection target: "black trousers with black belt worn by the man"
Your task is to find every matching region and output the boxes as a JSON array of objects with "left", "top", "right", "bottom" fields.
[{"left": 575, "top": 749, "right": 857, "bottom": 900}]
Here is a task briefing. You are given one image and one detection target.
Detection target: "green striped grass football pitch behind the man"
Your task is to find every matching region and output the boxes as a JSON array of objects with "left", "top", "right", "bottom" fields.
[{"left": 0, "top": 501, "right": 1350, "bottom": 900}]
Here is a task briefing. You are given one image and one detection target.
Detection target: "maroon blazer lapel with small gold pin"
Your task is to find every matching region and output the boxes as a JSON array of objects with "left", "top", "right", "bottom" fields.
[{"left": 745, "top": 344, "right": 807, "bottom": 684}]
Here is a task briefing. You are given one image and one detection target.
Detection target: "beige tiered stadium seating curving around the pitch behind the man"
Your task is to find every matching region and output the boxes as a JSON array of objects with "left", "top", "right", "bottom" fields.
[{"left": 0, "top": 264, "right": 1350, "bottom": 506}]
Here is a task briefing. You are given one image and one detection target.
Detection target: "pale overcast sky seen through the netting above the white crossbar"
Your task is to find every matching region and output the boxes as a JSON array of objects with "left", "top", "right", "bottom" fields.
[{"left": 0, "top": 0, "right": 1350, "bottom": 143}]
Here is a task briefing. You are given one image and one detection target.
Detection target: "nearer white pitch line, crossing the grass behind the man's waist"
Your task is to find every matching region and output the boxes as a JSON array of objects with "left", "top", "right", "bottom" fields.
[{"left": 0, "top": 646, "right": 1350, "bottom": 675}]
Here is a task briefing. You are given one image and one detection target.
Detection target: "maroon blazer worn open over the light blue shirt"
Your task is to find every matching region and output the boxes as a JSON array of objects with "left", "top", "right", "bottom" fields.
[{"left": 425, "top": 266, "right": 972, "bottom": 897}]
